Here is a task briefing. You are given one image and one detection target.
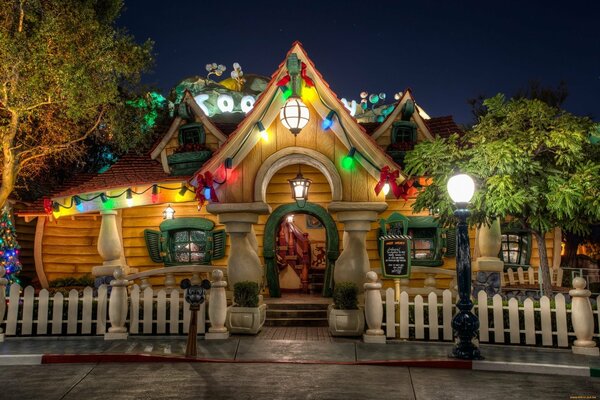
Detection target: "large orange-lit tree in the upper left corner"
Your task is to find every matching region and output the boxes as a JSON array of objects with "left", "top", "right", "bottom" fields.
[{"left": 0, "top": 0, "right": 152, "bottom": 207}]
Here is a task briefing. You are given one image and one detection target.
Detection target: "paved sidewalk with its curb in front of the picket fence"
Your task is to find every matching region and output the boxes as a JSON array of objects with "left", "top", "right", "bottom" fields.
[{"left": 0, "top": 336, "right": 600, "bottom": 377}]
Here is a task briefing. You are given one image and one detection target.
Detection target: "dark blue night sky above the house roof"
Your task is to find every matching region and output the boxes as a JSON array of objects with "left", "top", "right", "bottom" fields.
[{"left": 119, "top": 0, "right": 600, "bottom": 123}]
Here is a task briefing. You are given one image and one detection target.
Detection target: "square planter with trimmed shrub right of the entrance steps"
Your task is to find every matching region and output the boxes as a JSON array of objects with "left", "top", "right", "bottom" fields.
[{"left": 328, "top": 282, "right": 365, "bottom": 336}]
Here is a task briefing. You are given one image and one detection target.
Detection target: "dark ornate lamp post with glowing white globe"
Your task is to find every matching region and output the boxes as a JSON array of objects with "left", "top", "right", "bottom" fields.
[{"left": 448, "top": 174, "right": 483, "bottom": 360}]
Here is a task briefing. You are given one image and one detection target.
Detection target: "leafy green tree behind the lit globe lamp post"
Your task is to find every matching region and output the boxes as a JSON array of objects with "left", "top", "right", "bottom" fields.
[{"left": 406, "top": 95, "right": 600, "bottom": 295}]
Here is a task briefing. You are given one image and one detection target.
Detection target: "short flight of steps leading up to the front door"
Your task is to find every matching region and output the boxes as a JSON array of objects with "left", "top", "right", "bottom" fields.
[{"left": 265, "top": 302, "right": 328, "bottom": 326}]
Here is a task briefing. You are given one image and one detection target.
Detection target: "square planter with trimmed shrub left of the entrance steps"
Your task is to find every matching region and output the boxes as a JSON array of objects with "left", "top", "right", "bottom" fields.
[{"left": 226, "top": 281, "right": 267, "bottom": 335}]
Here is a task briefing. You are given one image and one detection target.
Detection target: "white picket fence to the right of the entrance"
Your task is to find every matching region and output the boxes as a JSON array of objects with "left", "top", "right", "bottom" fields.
[{"left": 384, "top": 288, "right": 600, "bottom": 347}]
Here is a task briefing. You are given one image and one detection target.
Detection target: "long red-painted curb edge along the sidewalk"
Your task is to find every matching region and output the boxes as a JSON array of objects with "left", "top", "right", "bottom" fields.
[{"left": 41, "top": 354, "right": 472, "bottom": 369}]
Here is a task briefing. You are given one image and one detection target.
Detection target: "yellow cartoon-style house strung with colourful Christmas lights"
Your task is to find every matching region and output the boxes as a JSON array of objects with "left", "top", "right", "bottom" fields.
[{"left": 18, "top": 43, "right": 560, "bottom": 297}]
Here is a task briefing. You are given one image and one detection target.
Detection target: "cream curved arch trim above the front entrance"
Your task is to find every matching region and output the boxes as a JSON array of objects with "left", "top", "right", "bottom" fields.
[{"left": 254, "top": 147, "right": 342, "bottom": 203}]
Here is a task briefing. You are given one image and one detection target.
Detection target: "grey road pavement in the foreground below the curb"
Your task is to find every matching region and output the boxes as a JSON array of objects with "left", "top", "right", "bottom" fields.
[{"left": 1, "top": 362, "right": 600, "bottom": 400}]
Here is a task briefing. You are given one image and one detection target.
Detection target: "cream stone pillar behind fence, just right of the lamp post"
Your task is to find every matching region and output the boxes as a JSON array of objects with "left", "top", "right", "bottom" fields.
[{"left": 472, "top": 218, "right": 504, "bottom": 298}]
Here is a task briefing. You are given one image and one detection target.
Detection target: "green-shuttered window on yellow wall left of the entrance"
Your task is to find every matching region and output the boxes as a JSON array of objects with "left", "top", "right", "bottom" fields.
[{"left": 144, "top": 218, "right": 226, "bottom": 266}]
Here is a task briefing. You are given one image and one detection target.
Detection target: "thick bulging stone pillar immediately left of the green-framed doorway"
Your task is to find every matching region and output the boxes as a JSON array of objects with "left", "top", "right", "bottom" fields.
[{"left": 206, "top": 203, "right": 271, "bottom": 287}]
